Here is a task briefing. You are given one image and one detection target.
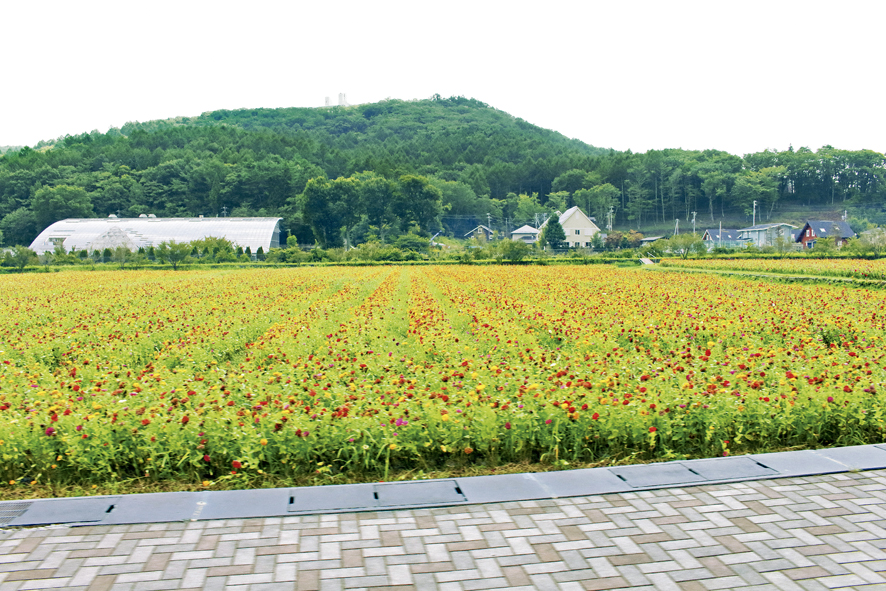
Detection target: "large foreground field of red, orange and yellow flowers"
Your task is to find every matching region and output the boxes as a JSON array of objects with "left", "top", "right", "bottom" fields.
[{"left": 0, "top": 265, "right": 886, "bottom": 486}]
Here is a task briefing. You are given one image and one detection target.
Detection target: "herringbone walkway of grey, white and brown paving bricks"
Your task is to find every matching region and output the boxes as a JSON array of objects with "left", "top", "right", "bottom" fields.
[{"left": 0, "top": 470, "right": 886, "bottom": 591}]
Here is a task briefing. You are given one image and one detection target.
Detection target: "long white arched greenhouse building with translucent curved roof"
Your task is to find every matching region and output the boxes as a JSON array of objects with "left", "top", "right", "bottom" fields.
[{"left": 31, "top": 216, "right": 283, "bottom": 254}]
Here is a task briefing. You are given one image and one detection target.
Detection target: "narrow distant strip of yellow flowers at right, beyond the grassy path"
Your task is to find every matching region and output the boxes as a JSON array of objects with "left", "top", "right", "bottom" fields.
[{"left": 665, "top": 258, "right": 886, "bottom": 281}]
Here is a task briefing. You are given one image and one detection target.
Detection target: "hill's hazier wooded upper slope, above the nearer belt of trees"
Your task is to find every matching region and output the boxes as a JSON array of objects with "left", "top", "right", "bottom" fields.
[{"left": 121, "top": 96, "right": 609, "bottom": 198}]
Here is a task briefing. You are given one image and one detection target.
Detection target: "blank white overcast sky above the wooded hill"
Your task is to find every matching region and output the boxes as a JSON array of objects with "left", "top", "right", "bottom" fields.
[{"left": 0, "top": 0, "right": 886, "bottom": 155}]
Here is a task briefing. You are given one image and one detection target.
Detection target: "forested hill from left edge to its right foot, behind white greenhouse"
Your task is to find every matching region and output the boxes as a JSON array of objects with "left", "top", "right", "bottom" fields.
[{"left": 0, "top": 97, "right": 609, "bottom": 245}]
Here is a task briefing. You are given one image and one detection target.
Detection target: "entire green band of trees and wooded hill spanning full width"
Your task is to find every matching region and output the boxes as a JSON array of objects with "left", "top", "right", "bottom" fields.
[{"left": 0, "top": 97, "right": 886, "bottom": 246}]
